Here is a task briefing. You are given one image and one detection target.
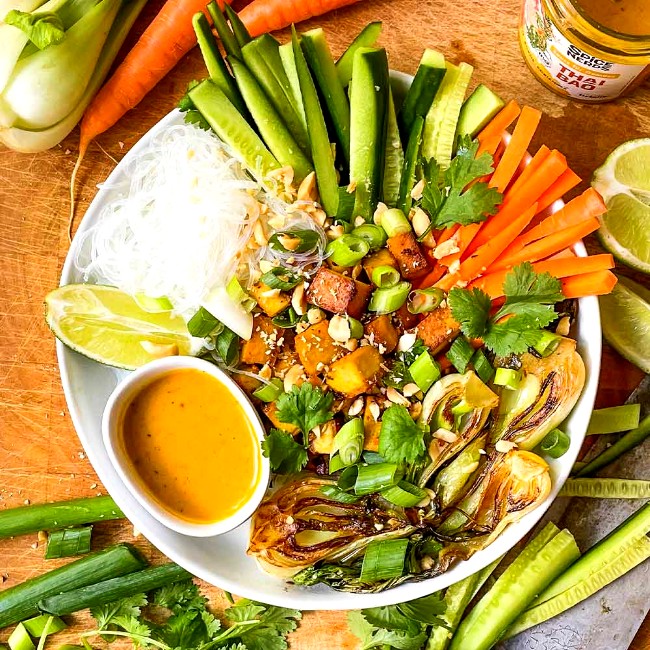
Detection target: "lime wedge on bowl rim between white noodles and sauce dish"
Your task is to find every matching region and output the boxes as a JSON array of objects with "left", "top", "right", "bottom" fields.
[{"left": 45, "top": 284, "right": 195, "bottom": 370}]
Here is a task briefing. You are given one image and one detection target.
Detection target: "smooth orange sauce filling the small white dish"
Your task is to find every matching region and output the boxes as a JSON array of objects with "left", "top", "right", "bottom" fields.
[{"left": 120, "top": 368, "right": 261, "bottom": 524}]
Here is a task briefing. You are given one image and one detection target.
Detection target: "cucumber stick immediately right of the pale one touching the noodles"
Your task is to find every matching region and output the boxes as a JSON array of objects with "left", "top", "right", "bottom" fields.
[{"left": 228, "top": 58, "right": 313, "bottom": 183}]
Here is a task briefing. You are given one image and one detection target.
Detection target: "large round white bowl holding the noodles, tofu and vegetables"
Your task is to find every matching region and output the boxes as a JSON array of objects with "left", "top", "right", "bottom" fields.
[{"left": 57, "top": 72, "right": 601, "bottom": 610}]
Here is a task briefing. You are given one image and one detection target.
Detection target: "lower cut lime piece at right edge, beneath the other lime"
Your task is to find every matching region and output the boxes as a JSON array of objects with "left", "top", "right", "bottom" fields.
[{"left": 598, "top": 276, "right": 650, "bottom": 372}]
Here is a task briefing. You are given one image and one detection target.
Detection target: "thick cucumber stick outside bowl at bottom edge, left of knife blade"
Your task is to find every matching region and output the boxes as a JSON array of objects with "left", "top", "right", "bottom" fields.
[{"left": 449, "top": 527, "right": 580, "bottom": 650}]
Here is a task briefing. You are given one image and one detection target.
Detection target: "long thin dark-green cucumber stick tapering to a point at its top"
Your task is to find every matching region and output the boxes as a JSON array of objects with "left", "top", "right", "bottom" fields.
[{"left": 291, "top": 28, "right": 339, "bottom": 217}]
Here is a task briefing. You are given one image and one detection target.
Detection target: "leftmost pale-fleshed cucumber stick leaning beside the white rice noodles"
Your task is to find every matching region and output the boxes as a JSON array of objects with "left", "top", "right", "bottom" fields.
[{"left": 189, "top": 79, "right": 280, "bottom": 180}]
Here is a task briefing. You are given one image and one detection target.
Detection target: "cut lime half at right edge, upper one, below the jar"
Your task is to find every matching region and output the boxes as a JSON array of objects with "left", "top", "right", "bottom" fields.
[{"left": 591, "top": 138, "right": 650, "bottom": 273}]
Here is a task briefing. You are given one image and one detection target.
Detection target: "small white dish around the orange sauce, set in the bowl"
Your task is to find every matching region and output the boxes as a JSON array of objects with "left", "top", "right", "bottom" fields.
[{"left": 102, "top": 356, "right": 270, "bottom": 537}]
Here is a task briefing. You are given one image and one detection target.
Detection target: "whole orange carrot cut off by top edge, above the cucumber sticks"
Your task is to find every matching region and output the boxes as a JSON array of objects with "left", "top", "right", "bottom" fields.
[{"left": 239, "top": 0, "right": 358, "bottom": 36}]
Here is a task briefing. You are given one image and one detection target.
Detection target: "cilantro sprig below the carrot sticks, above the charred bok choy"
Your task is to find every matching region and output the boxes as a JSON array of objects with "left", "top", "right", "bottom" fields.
[{"left": 448, "top": 262, "right": 564, "bottom": 356}]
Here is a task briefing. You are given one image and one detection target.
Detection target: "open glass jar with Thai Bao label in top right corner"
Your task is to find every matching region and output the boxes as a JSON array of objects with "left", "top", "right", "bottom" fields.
[{"left": 519, "top": 0, "right": 650, "bottom": 102}]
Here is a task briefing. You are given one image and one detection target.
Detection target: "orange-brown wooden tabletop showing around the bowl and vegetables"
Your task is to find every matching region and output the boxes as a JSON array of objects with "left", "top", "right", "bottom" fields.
[{"left": 0, "top": 0, "right": 650, "bottom": 650}]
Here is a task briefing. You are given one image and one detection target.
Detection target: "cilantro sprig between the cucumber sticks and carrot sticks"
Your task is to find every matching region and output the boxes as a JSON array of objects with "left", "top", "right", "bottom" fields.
[{"left": 421, "top": 136, "right": 503, "bottom": 235}]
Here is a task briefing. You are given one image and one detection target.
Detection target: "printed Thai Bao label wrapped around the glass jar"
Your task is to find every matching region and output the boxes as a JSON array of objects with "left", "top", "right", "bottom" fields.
[{"left": 520, "top": 0, "right": 645, "bottom": 102}]
